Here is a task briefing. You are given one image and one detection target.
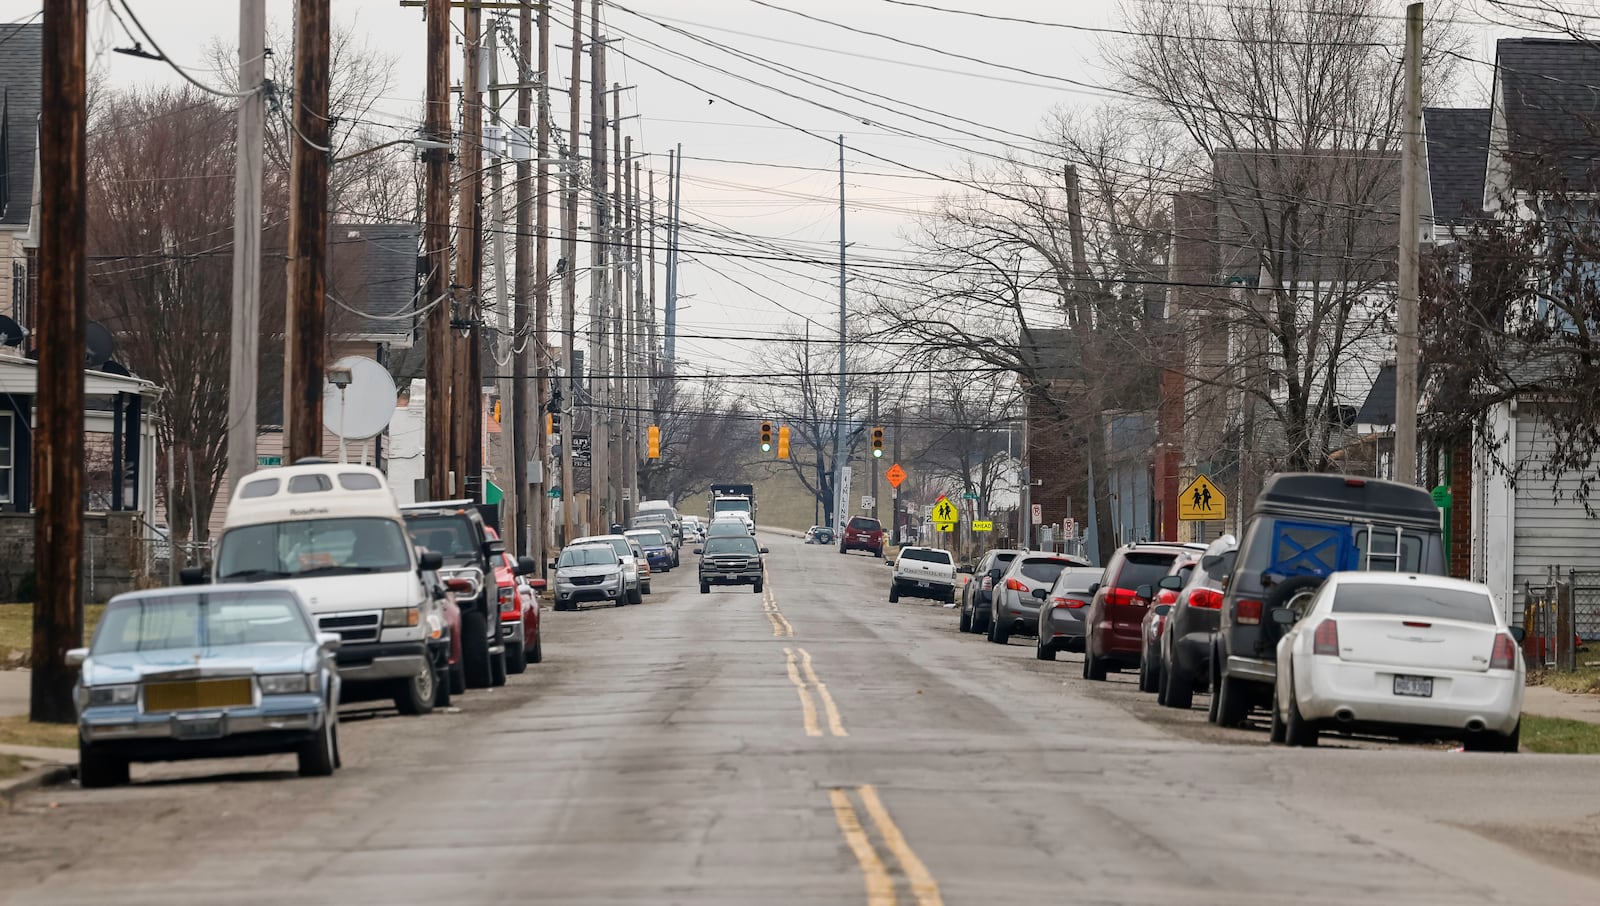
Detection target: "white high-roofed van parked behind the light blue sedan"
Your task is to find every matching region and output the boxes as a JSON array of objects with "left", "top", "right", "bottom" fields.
[{"left": 201, "top": 459, "right": 448, "bottom": 714}]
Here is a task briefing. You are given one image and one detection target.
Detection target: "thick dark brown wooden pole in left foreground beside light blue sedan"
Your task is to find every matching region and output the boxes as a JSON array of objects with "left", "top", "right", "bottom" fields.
[{"left": 29, "top": 0, "right": 88, "bottom": 724}]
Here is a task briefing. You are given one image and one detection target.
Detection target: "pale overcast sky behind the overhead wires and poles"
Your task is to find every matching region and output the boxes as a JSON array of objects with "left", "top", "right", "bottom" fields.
[{"left": 18, "top": 0, "right": 1523, "bottom": 371}]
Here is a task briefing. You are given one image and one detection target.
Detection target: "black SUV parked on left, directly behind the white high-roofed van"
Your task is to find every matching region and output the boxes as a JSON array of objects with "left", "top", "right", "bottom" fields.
[{"left": 400, "top": 499, "right": 506, "bottom": 688}]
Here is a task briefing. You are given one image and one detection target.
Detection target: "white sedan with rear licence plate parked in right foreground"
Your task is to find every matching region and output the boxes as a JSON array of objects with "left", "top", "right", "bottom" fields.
[{"left": 1272, "top": 573, "right": 1525, "bottom": 752}]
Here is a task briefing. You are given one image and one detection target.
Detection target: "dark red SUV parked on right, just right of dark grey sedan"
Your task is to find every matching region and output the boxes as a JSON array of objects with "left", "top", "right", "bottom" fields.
[{"left": 1083, "top": 541, "right": 1205, "bottom": 680}]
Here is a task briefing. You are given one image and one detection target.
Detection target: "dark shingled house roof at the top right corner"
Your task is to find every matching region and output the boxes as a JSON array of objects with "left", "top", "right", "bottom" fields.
[{"left": 1494, "top": 38, "right": 1600, "bottom": 187}]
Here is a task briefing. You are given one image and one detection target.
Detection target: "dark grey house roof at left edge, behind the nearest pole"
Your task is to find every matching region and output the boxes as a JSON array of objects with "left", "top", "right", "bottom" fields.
[{"left": 0, "top": 24, "right": 45, "bottom": 226}]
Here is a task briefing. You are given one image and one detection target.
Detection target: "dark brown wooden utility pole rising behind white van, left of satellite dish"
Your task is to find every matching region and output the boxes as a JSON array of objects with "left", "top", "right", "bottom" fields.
[{"left": 283, "top": 0, "right": 331, "bottom": 463}]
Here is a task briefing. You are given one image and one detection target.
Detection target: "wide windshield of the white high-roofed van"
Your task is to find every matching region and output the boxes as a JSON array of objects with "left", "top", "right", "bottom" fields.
[{"left": 216, "top": 517, "right": 411, "bottom": 581}]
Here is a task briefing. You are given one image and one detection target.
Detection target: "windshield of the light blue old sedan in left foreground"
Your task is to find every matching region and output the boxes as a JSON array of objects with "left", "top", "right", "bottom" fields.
[{"left": 91, "top": 591, "right": 312, "bottom": 655}]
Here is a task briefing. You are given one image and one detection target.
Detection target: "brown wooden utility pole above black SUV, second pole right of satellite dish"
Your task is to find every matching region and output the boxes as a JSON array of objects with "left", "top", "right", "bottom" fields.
[{"left": 451, "top": 3, "right": 483, "bottom": 499}]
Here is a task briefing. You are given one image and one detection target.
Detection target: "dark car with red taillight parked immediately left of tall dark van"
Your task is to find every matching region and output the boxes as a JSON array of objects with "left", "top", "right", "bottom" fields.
[{"left": 1155, "top": 535, "right": 1238, "bottom": 708}]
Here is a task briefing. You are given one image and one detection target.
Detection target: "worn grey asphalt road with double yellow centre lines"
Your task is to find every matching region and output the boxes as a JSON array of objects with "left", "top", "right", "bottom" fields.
[{"left": 0, "top": 536, "right": 1600, "bottom": 906}]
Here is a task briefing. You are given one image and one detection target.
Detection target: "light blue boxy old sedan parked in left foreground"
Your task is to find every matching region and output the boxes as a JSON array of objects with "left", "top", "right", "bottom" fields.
[{"left": 67, "top": 584, "right": 339, "bottom": 788}]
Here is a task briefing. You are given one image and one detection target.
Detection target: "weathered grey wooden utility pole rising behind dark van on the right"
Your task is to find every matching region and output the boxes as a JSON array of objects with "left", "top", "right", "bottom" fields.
[{"left": 1394, "top": 3, "right": 1422, "bottom": 485}]
